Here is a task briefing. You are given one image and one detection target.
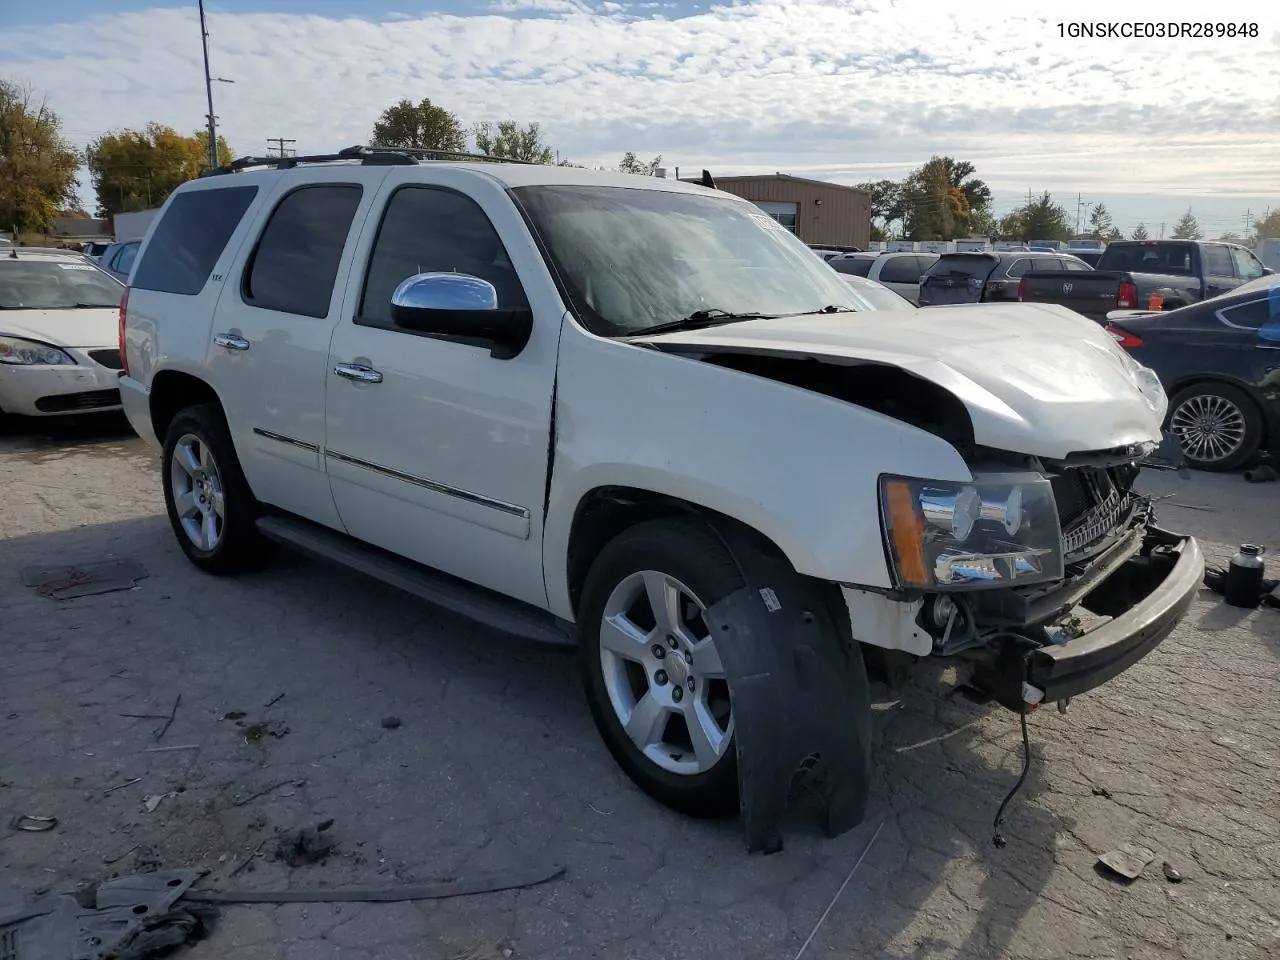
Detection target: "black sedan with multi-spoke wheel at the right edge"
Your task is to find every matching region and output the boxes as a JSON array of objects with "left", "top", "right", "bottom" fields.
[{"left": 1107, "top": 280, "right": 1280, "bottom": 470}]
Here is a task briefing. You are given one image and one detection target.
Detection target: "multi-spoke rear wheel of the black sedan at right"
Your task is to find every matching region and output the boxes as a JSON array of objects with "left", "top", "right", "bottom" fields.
[{"left": 1169, "top": 383, "right": 1262, "bottom": 471}]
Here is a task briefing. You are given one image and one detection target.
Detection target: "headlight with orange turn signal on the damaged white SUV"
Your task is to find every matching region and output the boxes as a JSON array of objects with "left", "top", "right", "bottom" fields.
[{"left": 881, "top": 474, "right": 1062, "bottom": 590}]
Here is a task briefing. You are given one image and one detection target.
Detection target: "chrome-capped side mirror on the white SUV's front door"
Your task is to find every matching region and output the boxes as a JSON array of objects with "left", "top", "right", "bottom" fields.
[{"left": 392, "top": 273, "right": 534, "bottom": 360}]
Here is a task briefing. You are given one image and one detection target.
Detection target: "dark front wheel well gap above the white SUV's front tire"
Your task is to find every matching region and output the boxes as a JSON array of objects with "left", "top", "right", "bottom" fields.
[{"left": 567, "top": 486, "right": 785, "bottom": 611}]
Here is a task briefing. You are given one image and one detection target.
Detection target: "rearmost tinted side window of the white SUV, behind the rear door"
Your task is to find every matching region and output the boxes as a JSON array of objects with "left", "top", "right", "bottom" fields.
[{"left": 133, "top": 187, "right": 257, "bottom": 297}]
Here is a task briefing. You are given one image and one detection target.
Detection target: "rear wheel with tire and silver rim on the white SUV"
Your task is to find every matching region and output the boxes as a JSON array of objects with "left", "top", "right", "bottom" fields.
[{"left": 163, "top": 404, "right": 271, "bottom": 573}]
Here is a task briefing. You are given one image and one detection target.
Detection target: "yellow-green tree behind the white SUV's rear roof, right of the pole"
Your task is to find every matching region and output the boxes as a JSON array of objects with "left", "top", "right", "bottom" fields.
[{"left": 84, "top": 123, "right": 232, "bottom": 216}]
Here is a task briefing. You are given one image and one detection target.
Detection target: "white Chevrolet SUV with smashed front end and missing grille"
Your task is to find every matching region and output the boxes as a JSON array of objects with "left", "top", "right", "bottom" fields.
[{"left": 120, "top": 148, "right": 1202, "bottom": 839}]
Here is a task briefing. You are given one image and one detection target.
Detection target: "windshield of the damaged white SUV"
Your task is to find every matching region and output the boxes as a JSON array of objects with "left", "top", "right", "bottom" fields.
[{"left": 513, "top": 186, "right": 859, "bottom": 337}]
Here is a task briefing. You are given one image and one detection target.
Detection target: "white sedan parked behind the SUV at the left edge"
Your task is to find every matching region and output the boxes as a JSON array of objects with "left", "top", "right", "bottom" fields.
[{"left": 0, "top": 247, "right": 124, "bottom": 417}]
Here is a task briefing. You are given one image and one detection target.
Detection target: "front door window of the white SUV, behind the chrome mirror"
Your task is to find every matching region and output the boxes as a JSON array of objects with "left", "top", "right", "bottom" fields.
[{"left": 358, "top": 187, "right": 529, "bottom": 326}]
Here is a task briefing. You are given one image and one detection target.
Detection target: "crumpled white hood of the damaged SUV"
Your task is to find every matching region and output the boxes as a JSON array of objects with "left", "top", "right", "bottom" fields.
[{"left": 634, "top": 303, "right": 1165, "bottom": 458}]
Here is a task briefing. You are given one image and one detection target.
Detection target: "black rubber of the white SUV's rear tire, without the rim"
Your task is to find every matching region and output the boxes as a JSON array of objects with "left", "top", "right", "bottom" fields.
[{"left": 160, "top": 403, "right": 274, "bottom": 575}]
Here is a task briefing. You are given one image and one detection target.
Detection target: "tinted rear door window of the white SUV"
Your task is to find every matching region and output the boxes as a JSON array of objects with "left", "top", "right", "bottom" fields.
[{"left": 241, "top": 183, "right": 364, "bottom": 317}]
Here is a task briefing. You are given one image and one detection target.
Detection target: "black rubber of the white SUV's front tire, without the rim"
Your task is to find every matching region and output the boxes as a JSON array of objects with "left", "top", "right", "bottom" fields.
[{"left": 579, "top": 518, "right": 744, "bottom": 817}]
